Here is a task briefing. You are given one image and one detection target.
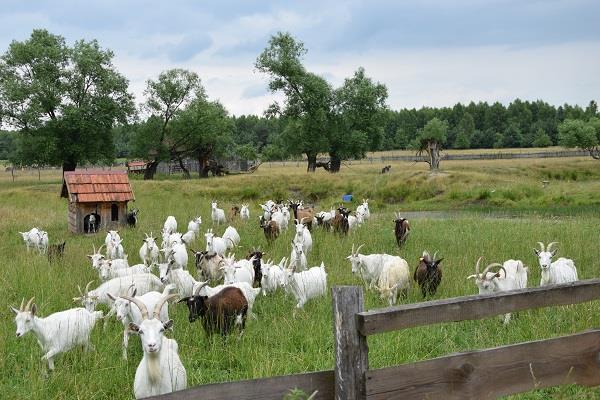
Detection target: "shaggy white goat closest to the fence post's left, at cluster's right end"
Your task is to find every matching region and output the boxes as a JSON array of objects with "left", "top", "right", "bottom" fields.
[{"left": 285, "top": 262, "right": 327, "bottom": 308}]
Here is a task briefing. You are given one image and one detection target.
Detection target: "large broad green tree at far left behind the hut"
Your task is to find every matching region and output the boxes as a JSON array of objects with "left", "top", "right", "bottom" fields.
[{"left": 0, "top": 29, "right": 134, "bottom": 177}]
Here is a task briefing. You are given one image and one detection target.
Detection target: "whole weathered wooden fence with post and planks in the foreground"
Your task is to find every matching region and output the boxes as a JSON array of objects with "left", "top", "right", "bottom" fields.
[{"left": 150, "top": 279, "right": 600, "bottom": 400}]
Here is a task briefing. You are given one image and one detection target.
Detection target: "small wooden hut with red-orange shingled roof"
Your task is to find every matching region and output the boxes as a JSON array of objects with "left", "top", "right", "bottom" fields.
[{"left": 63, "top": 171, "right": 135, "bottom": 233}]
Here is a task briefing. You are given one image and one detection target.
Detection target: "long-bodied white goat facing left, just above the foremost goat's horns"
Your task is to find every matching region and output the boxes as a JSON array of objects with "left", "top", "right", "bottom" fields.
[{"left": 73, "top": 274, "right": 164, "bottom": 312}]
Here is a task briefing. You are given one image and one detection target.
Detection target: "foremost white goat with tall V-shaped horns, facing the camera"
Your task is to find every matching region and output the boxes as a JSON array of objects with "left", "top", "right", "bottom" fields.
[{"left": 123, "top": 295, "right": 187, "bottom": 399}]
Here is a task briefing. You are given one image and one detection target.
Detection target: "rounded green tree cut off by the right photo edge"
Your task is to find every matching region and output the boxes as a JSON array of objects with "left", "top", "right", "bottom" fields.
[{"left": 558, "top": 118, "right": 600, "bottom": 160}]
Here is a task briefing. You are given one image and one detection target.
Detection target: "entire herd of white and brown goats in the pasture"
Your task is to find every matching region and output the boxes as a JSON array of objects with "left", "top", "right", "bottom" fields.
[{"left": 11, "top": 200, "right": 577, "bottom": 398}]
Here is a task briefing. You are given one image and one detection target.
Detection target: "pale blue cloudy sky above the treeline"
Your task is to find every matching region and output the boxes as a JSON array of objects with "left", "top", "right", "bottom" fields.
[{"left": 0, "top": 0, "right": 600, "bottom": 115}]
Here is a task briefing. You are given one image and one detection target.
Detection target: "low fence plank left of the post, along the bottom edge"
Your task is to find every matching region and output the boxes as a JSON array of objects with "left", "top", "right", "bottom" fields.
[{"left": 149, "top": 371, "right": 333, "bottom": 400}]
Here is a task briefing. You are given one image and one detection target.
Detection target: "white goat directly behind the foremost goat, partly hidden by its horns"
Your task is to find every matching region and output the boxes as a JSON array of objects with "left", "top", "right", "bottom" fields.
[{"left": 108, "top": 285, "right": 175, "bottom": 360}]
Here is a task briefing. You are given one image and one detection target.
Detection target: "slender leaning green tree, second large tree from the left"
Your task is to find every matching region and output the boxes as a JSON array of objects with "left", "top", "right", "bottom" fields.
[{"left": 132, "top": 69, "right": 206, "bottom": 179}]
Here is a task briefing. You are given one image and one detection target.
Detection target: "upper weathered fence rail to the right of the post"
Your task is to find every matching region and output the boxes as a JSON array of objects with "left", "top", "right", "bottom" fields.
[{"left": 356, "top": 279, "right": 600, "bottom": 335}]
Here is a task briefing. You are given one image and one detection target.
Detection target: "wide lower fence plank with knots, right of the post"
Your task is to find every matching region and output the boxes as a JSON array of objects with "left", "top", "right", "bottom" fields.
[{"left": 367, "top": 330, "right": 600, "bottom": 400}]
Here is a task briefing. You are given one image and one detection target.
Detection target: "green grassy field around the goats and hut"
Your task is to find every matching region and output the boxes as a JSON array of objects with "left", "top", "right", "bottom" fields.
[{"left": 0, "top": 158, "right": 600, "bottom": 399}]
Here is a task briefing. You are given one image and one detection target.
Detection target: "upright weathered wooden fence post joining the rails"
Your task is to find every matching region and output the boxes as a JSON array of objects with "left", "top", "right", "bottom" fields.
[{"left": 332, "top": 286, "right": 369, "bottom": 400}]
